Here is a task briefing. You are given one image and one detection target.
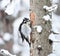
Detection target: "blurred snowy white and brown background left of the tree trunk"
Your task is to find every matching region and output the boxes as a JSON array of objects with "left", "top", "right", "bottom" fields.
[{"left": 0, "top": 0, "right": 30, "bottom": 56}]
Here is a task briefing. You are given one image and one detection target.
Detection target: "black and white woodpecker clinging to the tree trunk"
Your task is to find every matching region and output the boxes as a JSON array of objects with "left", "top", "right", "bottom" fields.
[{"left": 19, "top": 18, "right": 31, "bottom": 45}]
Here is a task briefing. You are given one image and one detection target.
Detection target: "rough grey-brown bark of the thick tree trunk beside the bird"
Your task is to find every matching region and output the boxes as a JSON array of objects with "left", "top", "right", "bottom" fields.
[{"left": 30, "top": 0, "right": 51, "bottom": 56}]
